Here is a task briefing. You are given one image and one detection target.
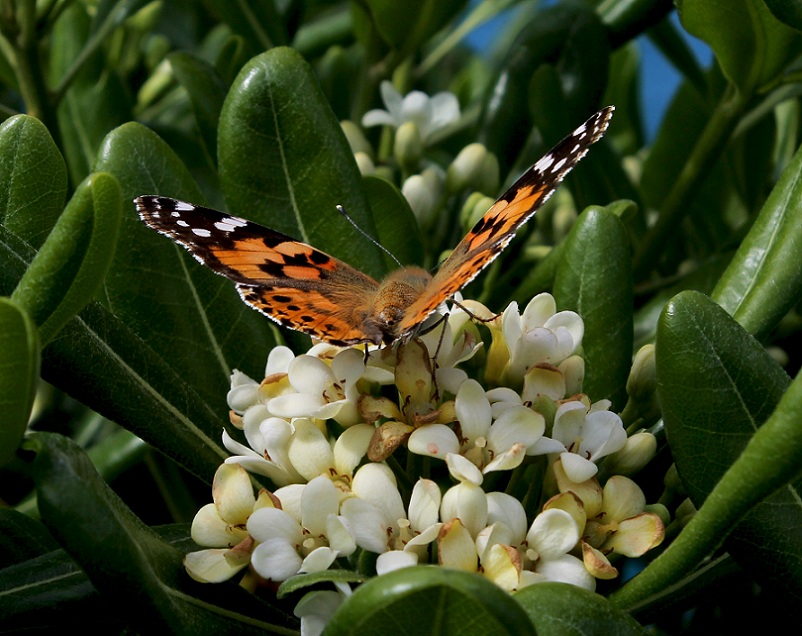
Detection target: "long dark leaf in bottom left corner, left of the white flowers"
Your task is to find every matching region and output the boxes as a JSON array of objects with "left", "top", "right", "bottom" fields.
[{"left": 18, "top": 433, "right": 289, "bottom": 634}]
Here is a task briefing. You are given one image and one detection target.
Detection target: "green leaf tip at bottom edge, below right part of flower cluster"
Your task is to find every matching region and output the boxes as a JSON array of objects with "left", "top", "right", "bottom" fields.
[{"left": 513, "top": 583, "right": 646, "bottom": 636}]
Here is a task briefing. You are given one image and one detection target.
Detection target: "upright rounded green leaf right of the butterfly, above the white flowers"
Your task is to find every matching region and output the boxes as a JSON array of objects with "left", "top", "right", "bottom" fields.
[{"left": 554, "top": 207, "right": 633, "bottom": 407}]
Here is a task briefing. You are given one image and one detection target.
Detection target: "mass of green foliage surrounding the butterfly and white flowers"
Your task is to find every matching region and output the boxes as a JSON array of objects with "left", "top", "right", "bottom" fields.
[{"left": 0, "top": 0, "right": 802, "bottom": 634}]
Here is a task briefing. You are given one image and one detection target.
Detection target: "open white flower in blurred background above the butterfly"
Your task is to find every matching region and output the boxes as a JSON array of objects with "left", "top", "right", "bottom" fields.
[{"left": 362, "top": 80, "right": 459, "bottom": 144}]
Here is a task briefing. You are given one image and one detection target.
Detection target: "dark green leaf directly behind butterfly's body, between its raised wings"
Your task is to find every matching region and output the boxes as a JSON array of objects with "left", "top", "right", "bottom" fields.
[{"left": 362, "top": 176, "right": 423, "bottom": 271}]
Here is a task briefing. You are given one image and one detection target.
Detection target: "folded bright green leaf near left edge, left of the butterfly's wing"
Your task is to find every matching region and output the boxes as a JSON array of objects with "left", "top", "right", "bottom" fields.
[{"left": 12, "top": 172, "right": 120, "bottom": 345}]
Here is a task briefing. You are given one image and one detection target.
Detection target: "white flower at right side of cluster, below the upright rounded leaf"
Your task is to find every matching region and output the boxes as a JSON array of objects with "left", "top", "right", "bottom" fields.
[{"left": 552, "top": 400, "right": 627, "bottom": 483}]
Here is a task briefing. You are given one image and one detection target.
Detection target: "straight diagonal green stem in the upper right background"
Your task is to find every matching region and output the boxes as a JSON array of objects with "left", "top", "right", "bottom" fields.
[{"left": 633, "top": 87, "right": 745, "bottom": 282}]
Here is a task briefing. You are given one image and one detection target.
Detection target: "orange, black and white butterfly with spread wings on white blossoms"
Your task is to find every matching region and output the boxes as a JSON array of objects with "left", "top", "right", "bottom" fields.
[{"left": 134, "top": 106, "right": 615, "bottom": 346}]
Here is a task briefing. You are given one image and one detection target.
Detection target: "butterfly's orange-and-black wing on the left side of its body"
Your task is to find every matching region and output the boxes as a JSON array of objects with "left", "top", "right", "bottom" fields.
[{"left": 134, "top": 196, "right": 378, "bottom": 345}]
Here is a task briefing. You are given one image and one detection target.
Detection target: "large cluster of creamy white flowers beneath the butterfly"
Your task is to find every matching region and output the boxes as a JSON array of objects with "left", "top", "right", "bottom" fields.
[{"left": 185, "top": 294, "right": 663, "bottom": 632}]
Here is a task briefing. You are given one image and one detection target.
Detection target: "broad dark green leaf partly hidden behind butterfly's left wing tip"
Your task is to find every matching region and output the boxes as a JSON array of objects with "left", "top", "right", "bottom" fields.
[{"left": 97, "top": 123, "right": 274, "bottom": 404}]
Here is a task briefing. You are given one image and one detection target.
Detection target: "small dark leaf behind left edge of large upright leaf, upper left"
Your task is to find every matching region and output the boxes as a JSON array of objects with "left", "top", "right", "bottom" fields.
[{"left": 167, "top": 51, "right": 227, "bottom": 163}]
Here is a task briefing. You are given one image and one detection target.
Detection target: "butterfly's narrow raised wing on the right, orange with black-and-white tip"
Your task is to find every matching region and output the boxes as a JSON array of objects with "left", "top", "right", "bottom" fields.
[{"left": 399, "top": 106, "right": 615, "bottom": 337}]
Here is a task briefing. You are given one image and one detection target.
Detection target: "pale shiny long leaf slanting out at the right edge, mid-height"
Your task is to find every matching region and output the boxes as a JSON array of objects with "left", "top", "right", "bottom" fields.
[{"left": 712, "top": 128, "right": 802, "bottom": 339}]
